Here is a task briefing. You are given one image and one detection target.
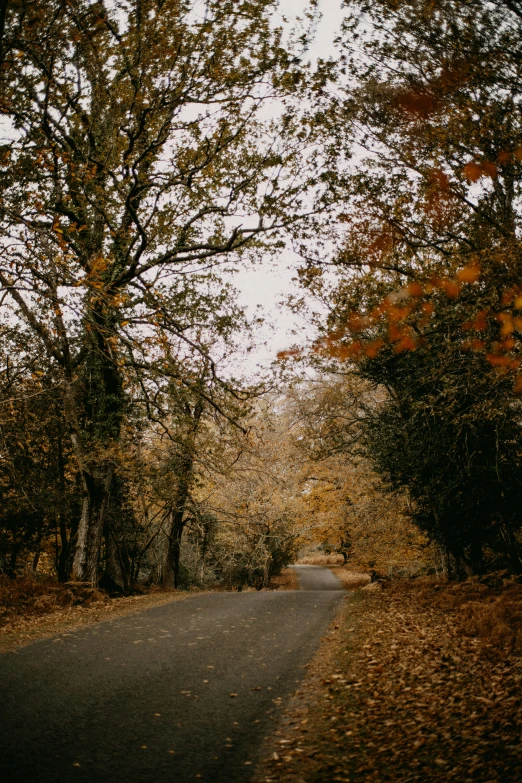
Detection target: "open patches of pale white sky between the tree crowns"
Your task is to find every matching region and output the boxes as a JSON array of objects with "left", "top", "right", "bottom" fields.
[{"left": 232, "top": 0, "right": 341, "bottom": 375}]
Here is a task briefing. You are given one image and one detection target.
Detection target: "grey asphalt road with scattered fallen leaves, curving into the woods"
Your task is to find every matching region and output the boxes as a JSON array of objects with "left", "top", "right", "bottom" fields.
[{"left": 0, "top": 567, "right": 345, "bottom": 783}]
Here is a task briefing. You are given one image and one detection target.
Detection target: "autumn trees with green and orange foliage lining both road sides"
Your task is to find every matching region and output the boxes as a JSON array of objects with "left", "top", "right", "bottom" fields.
[{"left": 0, "top": 0, "right": 522, "bottom": 591}]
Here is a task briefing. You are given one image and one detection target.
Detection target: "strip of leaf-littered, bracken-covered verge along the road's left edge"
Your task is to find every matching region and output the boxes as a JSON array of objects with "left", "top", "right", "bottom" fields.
[{"left": 0, "top": 568, "right": 299, "bottom": 653}]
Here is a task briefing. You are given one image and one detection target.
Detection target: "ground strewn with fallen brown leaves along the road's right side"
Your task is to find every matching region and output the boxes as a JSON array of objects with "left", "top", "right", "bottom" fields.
[{"left": 254, "top": 569, "right": 522, "bottom": 783}]
